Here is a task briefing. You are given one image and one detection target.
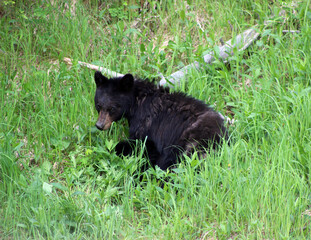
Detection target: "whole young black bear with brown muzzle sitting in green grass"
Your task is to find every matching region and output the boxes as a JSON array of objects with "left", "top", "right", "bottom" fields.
[{"left": 95, "top": 71, "right": 227, "bottom": 170}]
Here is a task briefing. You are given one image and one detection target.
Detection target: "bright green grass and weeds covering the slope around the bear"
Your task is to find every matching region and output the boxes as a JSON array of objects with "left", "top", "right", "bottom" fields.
[{"left": 0, "top": 0, "right": 311, "bottom": 239}]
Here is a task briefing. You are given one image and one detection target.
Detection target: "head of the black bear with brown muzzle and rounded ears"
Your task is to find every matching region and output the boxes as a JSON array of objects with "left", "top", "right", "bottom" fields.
[{"left": 94, "top": 71, "right": 134, "bottom": 130}]
